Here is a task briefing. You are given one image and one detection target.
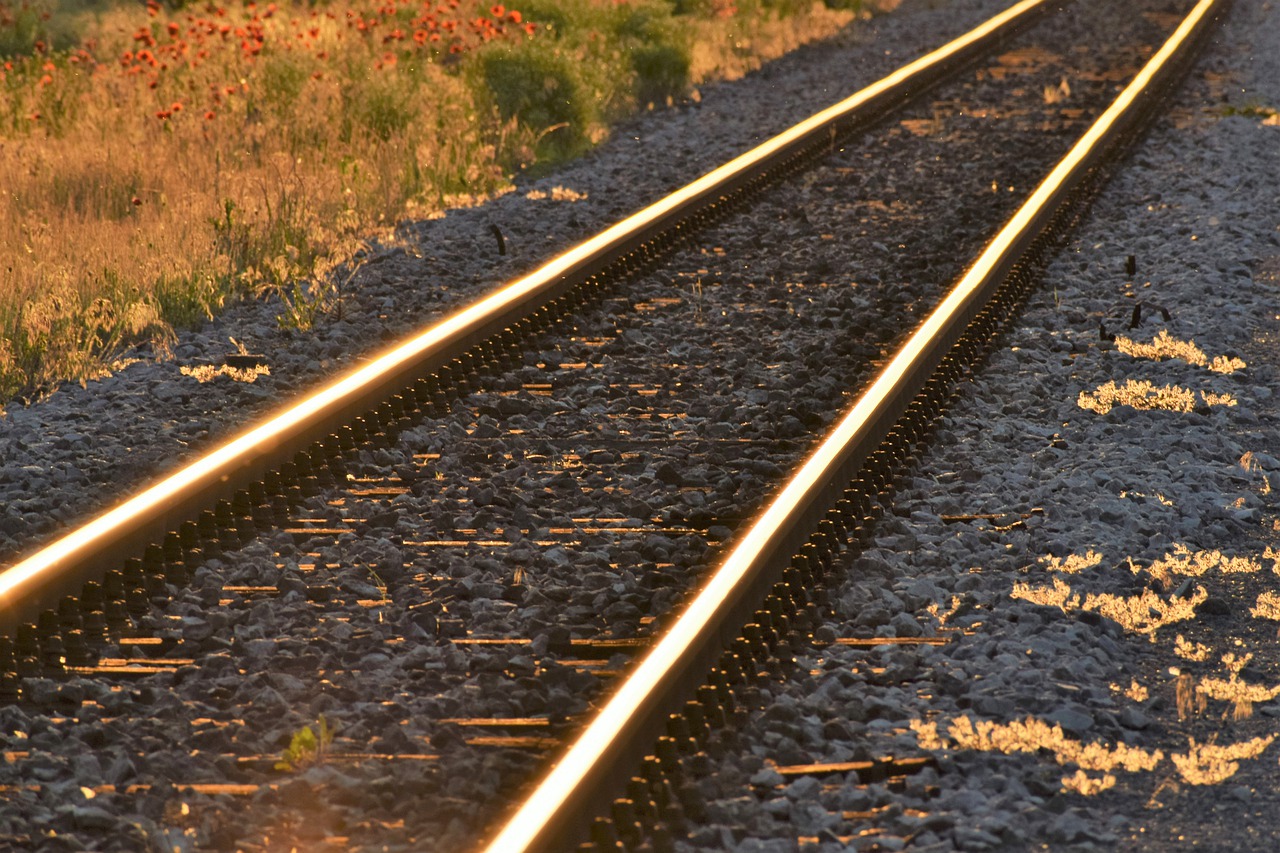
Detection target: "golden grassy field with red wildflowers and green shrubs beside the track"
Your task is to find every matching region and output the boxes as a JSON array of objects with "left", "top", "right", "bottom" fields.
[{"left": 0, "top": 0, "right": 861, "bottom": 405}]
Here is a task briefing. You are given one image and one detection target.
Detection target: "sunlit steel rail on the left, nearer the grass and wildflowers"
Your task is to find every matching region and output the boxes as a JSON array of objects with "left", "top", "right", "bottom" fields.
[{"left": 0, "top": 0, "right": 1057, "bottom": 631}]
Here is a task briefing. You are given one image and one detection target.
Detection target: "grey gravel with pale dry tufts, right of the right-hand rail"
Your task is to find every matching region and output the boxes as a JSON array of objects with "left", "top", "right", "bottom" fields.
[{"left": 682, "top": 1, "right": 1280, "bottom": 850}]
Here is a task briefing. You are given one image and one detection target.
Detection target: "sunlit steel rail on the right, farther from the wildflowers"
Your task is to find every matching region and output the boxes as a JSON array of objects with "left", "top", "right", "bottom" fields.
[{"left": 485, "top": 0, "right": 1228, "bottom": 853}]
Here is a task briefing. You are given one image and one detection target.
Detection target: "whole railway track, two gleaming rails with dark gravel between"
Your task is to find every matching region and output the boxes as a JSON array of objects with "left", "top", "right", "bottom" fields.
[{"left": 0, "top": 4, "right": 1228, "bottom": 850}]
